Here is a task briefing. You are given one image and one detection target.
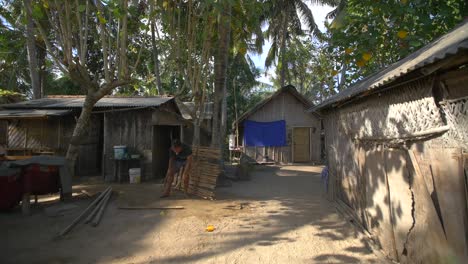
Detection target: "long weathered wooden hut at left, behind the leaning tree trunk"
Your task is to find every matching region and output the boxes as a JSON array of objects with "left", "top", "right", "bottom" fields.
[{"left": 0, "top": 96, "right": 184, "bottom": 181}]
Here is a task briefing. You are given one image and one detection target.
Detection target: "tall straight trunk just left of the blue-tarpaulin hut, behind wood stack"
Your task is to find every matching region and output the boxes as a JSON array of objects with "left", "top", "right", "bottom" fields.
[{"left": 211, "top": 1, "right": 231, "bottom": 148}]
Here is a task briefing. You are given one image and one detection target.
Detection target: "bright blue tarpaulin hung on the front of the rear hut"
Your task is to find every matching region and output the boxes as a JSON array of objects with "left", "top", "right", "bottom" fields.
[{"left": 244, "top": 120, "right": 286, "bottom": 147}]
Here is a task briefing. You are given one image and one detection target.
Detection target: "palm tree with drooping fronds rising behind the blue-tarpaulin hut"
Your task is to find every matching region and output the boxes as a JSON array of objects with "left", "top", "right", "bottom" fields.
[{"left": 265, "top": 0, "right": 340, "bottom": 87}]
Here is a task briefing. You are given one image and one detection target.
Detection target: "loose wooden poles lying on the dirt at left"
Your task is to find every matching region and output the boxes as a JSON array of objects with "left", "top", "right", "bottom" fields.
[{"left": 59, "top": 186, "right": 112, "bottom": 236}]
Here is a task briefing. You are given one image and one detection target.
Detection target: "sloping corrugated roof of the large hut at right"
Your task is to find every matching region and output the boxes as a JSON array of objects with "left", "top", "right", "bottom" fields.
[{"left": 309, "top": 20, "right": 468, "bottom": 111}]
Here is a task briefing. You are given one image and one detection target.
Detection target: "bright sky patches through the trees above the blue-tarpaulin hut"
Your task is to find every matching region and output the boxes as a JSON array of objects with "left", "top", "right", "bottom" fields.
[{"left": 249, "top": 3, "right": 333, "bottom": 85}]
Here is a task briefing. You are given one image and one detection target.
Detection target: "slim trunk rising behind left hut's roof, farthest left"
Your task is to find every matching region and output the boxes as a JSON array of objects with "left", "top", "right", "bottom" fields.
[{"left": 23, "top": 0, "right": 41, "bottom": 99}]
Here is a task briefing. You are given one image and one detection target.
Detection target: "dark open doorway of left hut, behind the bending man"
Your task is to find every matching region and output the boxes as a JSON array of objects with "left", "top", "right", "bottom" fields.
[{"left": 152, "top": 126, "right": 180, "bottom": 178}]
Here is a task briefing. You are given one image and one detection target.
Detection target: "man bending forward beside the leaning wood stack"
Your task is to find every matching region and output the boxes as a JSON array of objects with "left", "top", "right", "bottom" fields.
[{"left": 161, "top": 139, "right": 192, "bottom": 198}]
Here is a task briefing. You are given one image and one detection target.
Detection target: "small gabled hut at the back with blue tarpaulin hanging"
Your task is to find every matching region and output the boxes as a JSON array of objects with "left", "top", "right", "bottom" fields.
[{"left": 234, "top": 85, "right": 321, "bottom": 163}]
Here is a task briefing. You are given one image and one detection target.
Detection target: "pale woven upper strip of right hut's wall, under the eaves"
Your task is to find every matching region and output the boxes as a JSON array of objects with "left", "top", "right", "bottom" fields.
[{"left": 338, "top": 78, "right": 444, "bottom": 139}]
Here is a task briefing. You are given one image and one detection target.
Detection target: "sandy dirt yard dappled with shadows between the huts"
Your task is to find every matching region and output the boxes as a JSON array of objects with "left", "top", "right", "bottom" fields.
[{"left": 0, "top": 166, "right": 384, "bottom": 264}]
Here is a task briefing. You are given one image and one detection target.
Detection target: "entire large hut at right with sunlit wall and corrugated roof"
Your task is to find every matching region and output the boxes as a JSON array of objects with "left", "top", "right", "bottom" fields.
[{"left": 311, "top": 21, "right": 468, "bottom": 263}]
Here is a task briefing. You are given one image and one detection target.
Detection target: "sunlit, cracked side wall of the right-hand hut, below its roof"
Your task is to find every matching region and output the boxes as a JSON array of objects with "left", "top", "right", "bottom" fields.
[{"left": 324, "top": 75, "right": 468, "bottom": 263}]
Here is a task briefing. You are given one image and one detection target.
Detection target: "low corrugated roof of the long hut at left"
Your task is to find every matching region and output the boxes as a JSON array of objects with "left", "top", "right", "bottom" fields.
[{"left": 0, "top": 96, "right": 173, "bottom": 109}]
